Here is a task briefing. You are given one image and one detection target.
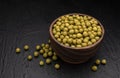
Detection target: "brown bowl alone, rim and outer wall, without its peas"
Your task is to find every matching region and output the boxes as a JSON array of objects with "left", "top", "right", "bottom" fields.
[{"left": 49, "top": 13, "right": 105, "bottom": 64}]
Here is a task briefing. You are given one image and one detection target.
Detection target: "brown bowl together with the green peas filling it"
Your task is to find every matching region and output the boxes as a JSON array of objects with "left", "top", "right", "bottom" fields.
[{"left": 49, "top": 13, "right": 104, "bottom": 64}]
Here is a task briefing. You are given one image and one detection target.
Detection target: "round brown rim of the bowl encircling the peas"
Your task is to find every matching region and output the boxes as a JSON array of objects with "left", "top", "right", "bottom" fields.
[{"left": 49, "top": 13, "right": 105, "bottom": 50}]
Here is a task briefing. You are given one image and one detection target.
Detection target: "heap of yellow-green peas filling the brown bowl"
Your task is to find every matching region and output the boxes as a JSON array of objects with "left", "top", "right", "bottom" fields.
[{"left": 52, "top": 14, "right": 102, "bottom": 47}]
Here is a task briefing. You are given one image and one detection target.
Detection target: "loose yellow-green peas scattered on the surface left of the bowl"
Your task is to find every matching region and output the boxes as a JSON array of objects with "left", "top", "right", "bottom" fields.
[{"left": 16, "top": 40, "right": 60, "bottom": 69}]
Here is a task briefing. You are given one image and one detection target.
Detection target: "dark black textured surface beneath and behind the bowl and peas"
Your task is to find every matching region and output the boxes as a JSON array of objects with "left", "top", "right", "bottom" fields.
[{"left": 0, "top": 0, "right": 120, "bottom": 78}]
